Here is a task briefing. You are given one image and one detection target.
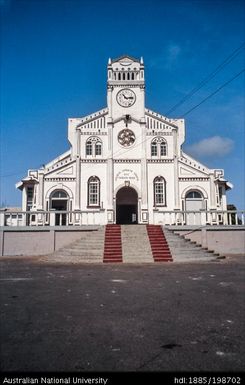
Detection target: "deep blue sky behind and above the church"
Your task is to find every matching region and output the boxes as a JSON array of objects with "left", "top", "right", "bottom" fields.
[{"left": 0, "top": 0, "right": 245, "bottom": 209}]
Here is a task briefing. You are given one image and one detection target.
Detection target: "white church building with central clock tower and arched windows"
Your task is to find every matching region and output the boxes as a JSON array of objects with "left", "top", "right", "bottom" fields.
[{"left": 16, "top": 56, "right": 231, "bottom": 225}]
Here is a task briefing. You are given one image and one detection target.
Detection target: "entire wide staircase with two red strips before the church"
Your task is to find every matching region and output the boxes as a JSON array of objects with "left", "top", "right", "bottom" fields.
[{"left": 40, "top": 225, "right": 224, "bottom": 263}]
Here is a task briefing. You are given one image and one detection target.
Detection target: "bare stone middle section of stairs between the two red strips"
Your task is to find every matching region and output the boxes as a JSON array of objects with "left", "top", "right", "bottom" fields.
[{"left": 121, "top": 225, "right": 154, "bottom": 263}]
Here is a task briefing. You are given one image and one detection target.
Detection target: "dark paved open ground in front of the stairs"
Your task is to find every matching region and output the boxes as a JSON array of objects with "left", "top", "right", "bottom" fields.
[{"left": 0, "top": 258, "right": 245, "bottom": 372}]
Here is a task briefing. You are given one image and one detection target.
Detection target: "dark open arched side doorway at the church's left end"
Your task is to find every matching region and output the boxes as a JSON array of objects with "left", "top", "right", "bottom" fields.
[{"left": 50, "top": 190, "right": 69, "bottom": 226}]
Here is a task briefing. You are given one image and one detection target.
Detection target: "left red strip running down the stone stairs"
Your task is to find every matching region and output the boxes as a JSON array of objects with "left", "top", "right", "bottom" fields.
[{"left": 103, "top": 225, "right": 122, "bottom": 263}]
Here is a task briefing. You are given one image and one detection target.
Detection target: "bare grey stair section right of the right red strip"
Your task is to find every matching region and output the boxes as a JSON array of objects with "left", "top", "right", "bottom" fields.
[{"left": 163, "top": 228, "right": 219, "bottom": 262}]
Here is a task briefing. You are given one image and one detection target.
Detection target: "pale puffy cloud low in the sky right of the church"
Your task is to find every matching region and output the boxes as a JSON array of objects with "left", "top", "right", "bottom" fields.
[{"left": 186, "top": 136, "right": 234, "bottom": 158}]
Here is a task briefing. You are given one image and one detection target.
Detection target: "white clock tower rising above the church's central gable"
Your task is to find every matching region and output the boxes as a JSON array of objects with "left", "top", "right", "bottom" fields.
[{"left": 107, "top": 55, "right": 145, "bottom": 121}]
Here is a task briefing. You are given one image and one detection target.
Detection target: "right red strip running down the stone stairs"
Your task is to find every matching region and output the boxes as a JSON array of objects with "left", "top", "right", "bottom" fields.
[{"left": 147, "top": 225, "right": 173, "bottom": 262}]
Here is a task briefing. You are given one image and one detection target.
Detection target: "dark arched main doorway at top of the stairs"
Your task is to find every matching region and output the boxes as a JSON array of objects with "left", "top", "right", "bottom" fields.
[{"left": 116, "top": 186, "right": 138, "bottom": 225}]
